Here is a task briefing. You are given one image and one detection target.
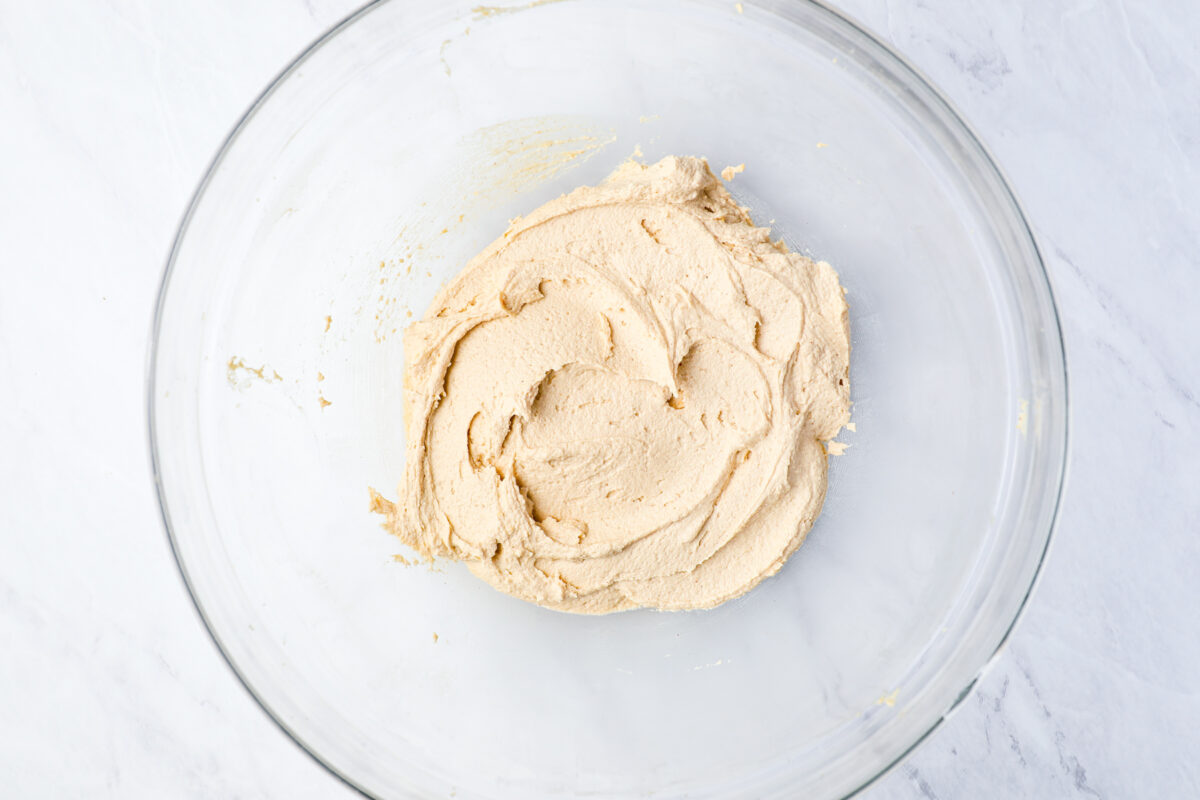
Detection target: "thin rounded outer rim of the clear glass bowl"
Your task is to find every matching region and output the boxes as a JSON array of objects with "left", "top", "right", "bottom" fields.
[{"left": 145, "top": 0, "right": 1070, "bottom": 800}]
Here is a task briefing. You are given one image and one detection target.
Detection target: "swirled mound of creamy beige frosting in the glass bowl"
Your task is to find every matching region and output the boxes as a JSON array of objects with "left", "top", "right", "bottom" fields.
[{"left": 372, "top": 157, "right": 850, "bottom": 614}]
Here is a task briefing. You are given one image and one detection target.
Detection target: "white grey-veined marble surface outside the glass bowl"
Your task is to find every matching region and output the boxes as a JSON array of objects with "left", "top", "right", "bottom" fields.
[{"left": 0, "top": 0, "right": 1200, "bottom": 800}]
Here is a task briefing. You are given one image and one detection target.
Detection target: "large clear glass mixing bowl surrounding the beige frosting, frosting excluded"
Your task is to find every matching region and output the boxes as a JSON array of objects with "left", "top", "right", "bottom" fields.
[{"left": 149, "top": 0, "right": 1067, "bottom": 799}]
